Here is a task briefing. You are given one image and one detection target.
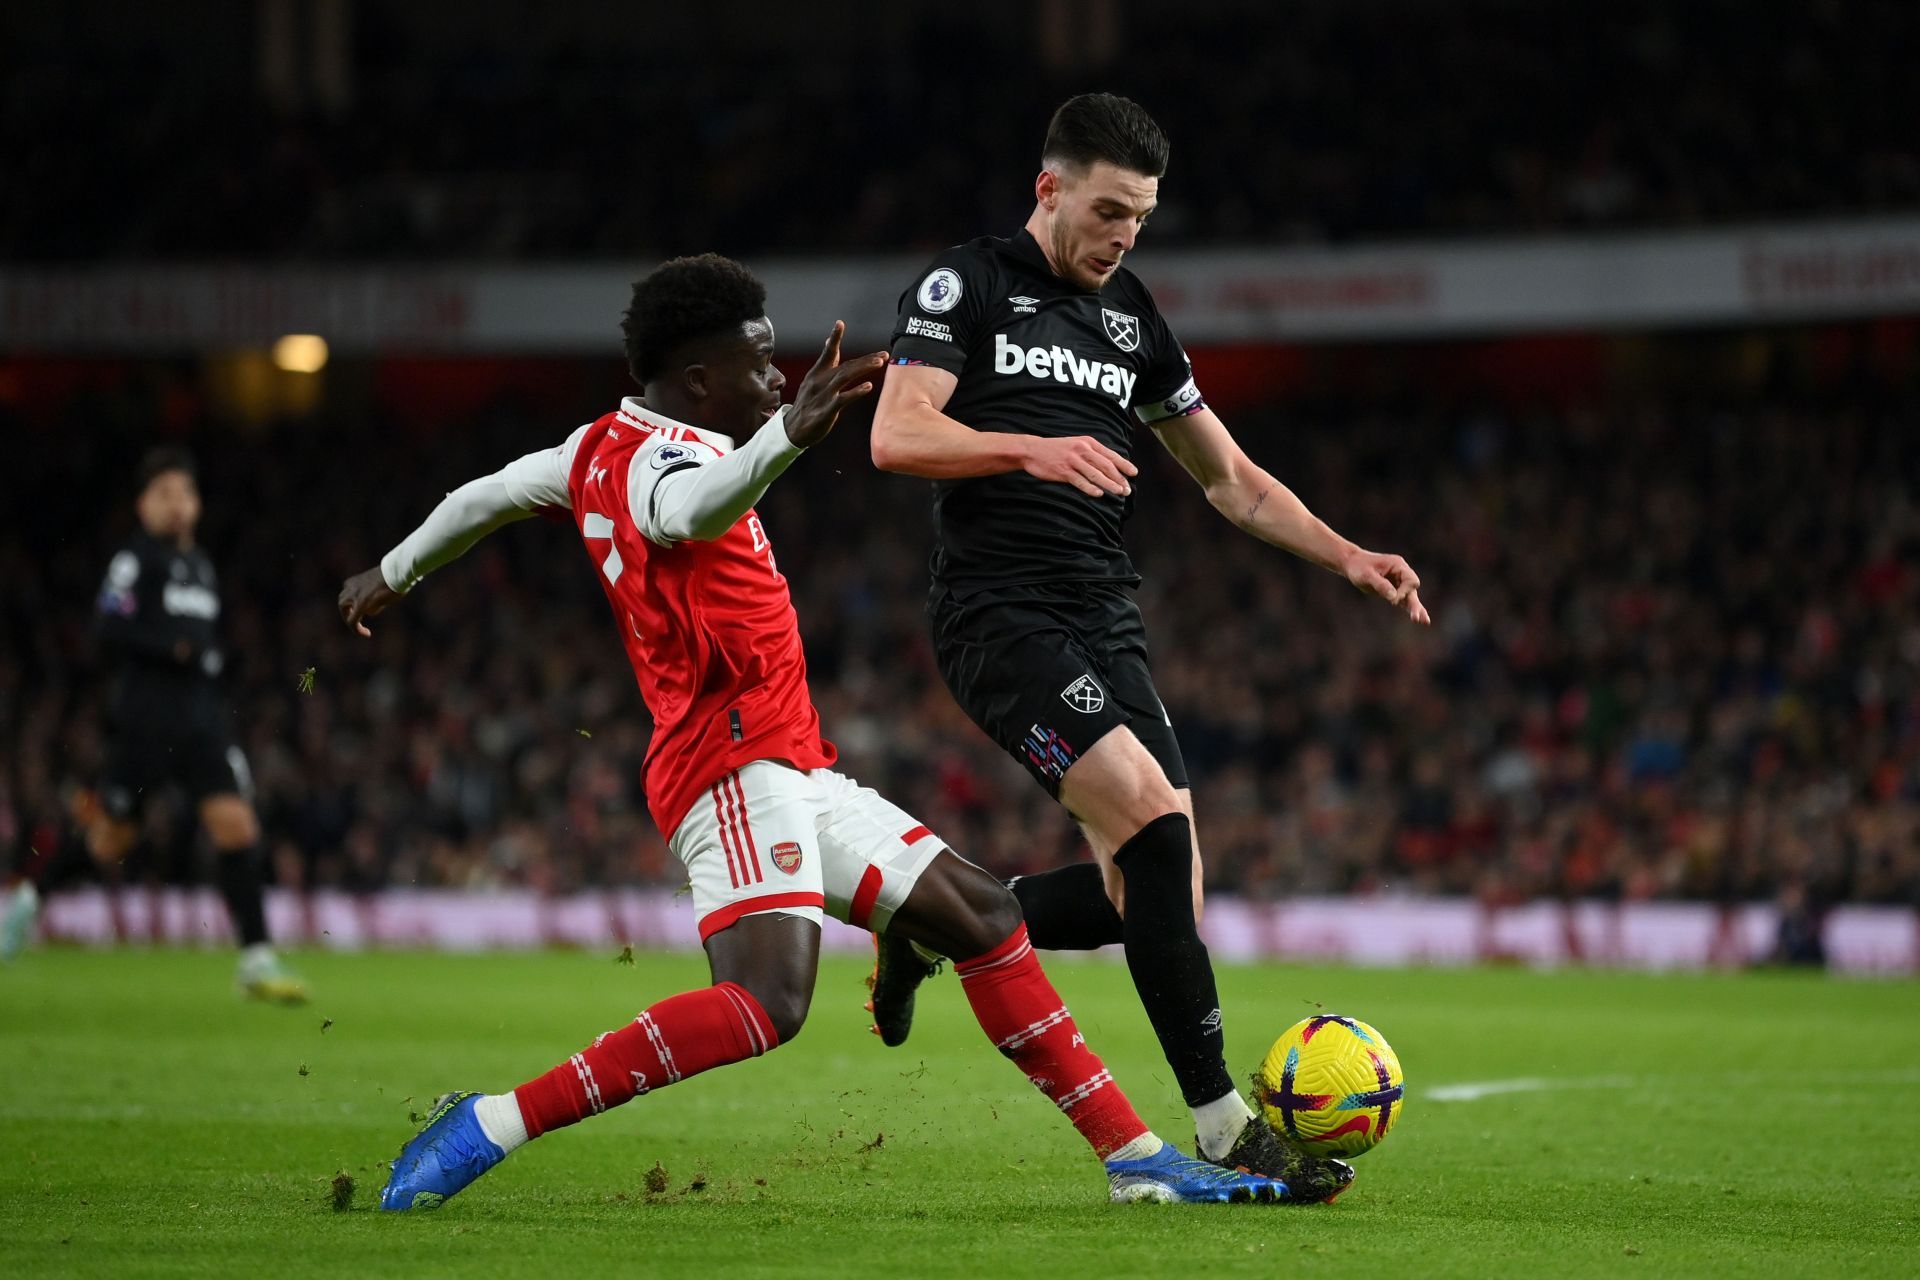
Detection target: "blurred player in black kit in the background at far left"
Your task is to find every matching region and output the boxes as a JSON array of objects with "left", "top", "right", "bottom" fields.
[{"left": 4, "top": 449, "right": 307, "bottom": 1004}]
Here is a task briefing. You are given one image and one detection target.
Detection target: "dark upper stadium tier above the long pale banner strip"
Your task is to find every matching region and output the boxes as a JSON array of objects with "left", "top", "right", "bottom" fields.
[{"left": 0, "top": 0, "right": 1920, "bottom": 261}]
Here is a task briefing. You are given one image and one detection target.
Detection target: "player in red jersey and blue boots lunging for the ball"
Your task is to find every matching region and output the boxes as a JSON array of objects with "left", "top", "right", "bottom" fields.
[{"left": 340, "top": 253, "right": 1288, "bottom": 1209}]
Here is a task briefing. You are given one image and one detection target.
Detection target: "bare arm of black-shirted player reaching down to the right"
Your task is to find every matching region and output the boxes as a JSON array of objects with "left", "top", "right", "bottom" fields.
[{"left": 1154, "top": 409, "right": 1432, "bottom": 626}]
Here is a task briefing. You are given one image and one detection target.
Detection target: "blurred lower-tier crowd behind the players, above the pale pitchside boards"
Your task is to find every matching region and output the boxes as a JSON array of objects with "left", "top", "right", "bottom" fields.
[{"left": 0, "top": 370, "right": 1920, "bottom": 906}]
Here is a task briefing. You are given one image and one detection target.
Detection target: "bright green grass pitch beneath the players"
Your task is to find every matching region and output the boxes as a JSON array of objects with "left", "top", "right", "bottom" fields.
[{"left": 0, "top": 950, "right": 1920, "bottom": 1280}]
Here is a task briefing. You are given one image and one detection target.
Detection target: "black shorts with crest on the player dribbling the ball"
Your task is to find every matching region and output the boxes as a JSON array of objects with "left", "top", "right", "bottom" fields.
[{"left": 927, "top": 583, "right": 1187, "bottom": 800}]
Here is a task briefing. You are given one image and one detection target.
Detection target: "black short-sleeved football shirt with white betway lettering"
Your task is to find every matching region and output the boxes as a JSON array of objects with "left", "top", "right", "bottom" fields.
[{"left": 893, "top": 230, "right": 1200, "bottom": 595}]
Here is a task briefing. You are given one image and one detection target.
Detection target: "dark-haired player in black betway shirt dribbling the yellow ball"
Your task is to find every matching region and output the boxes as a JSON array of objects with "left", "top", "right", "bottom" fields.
[{"left": 872, "top": 94, "right": 1428, "bottom": 1199}]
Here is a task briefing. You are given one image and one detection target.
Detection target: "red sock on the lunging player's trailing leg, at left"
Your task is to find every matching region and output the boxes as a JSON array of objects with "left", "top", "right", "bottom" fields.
[{"left": 513, "top": 983, "right": 780, "bottom": 1138}]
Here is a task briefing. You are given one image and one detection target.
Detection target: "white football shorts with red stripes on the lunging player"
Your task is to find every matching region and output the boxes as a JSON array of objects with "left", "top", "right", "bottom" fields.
[{"left": 668, "top": 760, "right": 947, "bottom": 942}]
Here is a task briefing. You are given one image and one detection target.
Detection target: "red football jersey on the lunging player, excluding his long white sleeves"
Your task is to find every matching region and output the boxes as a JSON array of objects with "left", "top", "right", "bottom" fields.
[{"left": 566, "top": 399, "right": 837, "bottom": 837}]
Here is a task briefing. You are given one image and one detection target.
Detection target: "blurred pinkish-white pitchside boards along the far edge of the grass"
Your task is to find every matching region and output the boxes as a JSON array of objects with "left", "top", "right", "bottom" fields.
[{"left": 30, "top": 889, "right": 1920, "bottom": 975}]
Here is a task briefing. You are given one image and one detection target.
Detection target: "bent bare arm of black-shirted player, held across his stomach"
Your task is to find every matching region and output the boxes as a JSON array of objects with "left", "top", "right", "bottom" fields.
[{"left": 872, "top": 365, "right": 1140, "bottom": 497}]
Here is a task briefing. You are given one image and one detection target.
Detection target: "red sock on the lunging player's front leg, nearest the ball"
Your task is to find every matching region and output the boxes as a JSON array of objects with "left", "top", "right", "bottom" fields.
[{"left": 954, "top": 925, "right": 1146, "bottom": 1159}]
